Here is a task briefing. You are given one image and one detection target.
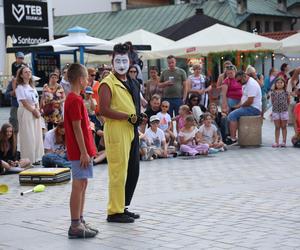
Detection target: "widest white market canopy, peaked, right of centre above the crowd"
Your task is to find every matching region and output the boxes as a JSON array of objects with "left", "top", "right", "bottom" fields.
[{"left": 156, "top": 24, "right": 282, "bottom": 57}]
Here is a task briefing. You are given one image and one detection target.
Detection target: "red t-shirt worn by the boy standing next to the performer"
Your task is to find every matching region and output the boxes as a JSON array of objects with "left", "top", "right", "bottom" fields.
[{"left": 64, "top": 92, "right": 96, "bottom": 161}]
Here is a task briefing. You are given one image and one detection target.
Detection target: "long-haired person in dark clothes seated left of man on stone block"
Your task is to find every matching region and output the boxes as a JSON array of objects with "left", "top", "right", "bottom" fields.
[{"left": 208, "top": 103, "right": 228, "bottom": 141}]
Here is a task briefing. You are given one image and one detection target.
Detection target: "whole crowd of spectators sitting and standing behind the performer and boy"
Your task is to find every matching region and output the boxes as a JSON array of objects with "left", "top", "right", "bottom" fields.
[{"left": 0, "top": 48, "right": 300, "bottom": 173}]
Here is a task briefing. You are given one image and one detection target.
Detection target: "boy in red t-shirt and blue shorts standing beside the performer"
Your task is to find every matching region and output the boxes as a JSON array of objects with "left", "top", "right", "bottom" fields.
[{"left": 64, "top": 63, "right": 98, "bottom": 239}]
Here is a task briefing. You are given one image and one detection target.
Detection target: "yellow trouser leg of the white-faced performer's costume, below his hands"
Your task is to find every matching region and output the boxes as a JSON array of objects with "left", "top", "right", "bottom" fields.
[{"left": 104, "top": 120, "right": 134, "bottom": 215}]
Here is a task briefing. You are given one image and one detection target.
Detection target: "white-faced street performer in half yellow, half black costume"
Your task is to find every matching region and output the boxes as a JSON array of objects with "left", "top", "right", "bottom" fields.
[{"left": 99, "top": 44, "right": 145, "bottom": 223}]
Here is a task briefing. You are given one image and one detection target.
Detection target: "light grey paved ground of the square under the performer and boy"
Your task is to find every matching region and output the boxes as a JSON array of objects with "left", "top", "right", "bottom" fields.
[{"left": 0, "top": 106, "right": 300, "bottom": 250}]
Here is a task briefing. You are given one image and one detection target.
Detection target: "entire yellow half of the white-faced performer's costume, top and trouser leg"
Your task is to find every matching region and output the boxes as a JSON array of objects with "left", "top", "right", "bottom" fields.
[{"left": 100, "top": 73, "right": 136, "bottom": 215}]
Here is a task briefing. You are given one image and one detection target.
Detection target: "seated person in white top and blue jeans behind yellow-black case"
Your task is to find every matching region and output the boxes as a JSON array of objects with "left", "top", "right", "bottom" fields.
[{"left": 42, "top": 121, "right": 71, "bottom": 168}]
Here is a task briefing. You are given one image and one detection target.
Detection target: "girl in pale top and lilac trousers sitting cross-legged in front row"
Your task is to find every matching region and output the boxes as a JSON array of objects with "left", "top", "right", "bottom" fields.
[{"left": 178, "top": 115, "right": 209, "bottom": 156}]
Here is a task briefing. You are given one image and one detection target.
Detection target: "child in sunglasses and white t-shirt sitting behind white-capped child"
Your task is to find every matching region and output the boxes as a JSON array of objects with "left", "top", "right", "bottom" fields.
[{"left": 157, "top": 101, "right": 176, "bottom": 145}]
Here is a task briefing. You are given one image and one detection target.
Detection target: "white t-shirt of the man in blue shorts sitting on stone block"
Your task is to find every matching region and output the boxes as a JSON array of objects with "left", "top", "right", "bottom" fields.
[{"left": 241, "top": 77, "right": 262, "bottom": 111}]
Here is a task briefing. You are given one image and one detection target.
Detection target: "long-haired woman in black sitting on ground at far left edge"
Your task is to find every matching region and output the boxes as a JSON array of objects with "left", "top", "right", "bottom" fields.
[{"left": 0, "top": 123, "right": 31, "bottom": 173}]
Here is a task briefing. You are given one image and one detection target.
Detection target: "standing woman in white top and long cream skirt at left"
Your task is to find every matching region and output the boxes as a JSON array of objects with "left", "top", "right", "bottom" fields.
[{"left": 16, "top": 66, "right": 44, "bottom": 163}]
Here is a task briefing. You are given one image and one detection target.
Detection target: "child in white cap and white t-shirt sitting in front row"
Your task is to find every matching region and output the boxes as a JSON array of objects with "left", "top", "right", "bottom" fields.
[{"left": 145, "top": 115, "right": 168, "bottom": 158}]
